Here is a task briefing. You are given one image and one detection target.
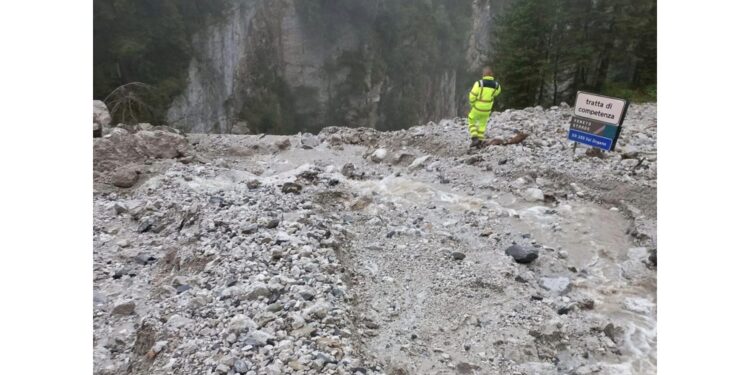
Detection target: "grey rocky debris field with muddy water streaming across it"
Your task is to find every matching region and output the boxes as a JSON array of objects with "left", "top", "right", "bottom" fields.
[{"left": 93, "top": 104, "right": 656, "bottom": 375}]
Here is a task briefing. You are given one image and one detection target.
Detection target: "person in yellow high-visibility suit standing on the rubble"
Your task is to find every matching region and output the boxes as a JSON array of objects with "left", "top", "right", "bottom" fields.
[{"left": 469, "top": 67, "right": 500, "bottom": 148}]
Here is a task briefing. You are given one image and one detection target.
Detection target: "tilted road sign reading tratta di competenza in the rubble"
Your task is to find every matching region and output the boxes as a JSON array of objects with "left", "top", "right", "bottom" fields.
[{"left": 568, "top": 91, "right": 629, "bottom": 151}]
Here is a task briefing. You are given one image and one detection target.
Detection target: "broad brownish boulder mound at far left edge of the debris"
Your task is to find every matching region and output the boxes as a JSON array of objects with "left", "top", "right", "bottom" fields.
[{"left": 94, "top": 127, "right": 190, "bottom": 172}]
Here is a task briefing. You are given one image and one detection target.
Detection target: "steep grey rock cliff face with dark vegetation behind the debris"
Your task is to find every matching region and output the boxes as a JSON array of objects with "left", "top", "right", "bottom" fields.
[{"left": 168, "top": 0, "right": 500, "bottom": 133}]
